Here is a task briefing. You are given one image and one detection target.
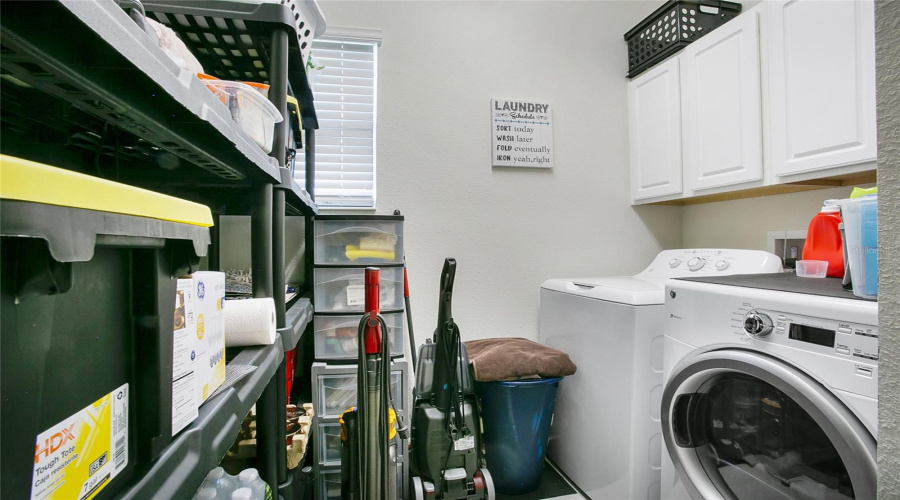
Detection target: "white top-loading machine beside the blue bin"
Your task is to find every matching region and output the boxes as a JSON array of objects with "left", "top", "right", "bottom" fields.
[{"left": 539, "top": 249, "right": 782, "bottom": 500}]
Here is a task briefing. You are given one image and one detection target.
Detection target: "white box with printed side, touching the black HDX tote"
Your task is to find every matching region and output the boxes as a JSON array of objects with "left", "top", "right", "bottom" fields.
[{"left": 172, "top": 278, "right": 200, "bottom": 436}]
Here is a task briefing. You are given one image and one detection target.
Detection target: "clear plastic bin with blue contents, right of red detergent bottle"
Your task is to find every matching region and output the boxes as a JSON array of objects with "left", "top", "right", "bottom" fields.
[{"left": 840, "top": 195, "right": 878, "bottom": 299}]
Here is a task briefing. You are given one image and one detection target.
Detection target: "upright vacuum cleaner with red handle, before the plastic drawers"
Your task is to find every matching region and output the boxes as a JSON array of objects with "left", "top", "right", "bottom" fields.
[{"left": 340, "top": 267, "right": 405, "bottom": 500}]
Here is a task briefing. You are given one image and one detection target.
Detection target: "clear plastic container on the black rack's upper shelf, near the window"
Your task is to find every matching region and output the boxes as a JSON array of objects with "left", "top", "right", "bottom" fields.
[{"left": 202, "top": 78, "right": 284, "bottom": 153}]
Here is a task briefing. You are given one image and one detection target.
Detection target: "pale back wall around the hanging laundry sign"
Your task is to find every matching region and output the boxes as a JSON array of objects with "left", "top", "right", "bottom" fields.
[{"left": 319, "top": 0, "right": 681, "bottom": 342}]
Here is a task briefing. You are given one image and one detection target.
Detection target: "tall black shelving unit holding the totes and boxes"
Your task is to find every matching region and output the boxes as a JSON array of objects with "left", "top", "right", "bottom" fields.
[{"left": 0, "top": 0, "right": 318, "bottom": 498}]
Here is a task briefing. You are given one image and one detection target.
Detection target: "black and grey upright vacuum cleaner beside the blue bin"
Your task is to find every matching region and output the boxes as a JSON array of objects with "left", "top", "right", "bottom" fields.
[{"left": 410, "top": 259, "right": 495, "bottom": 500}]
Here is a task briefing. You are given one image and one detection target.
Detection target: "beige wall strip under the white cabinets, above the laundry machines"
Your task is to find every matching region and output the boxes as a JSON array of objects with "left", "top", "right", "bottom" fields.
[{"left": 681, "top": 184, "right": 871, "bottom": 250}]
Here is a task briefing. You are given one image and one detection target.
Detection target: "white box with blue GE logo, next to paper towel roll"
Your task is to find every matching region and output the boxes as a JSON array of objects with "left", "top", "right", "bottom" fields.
[{"left": 191, "top": 271, "right": 225, "bottom": 404}]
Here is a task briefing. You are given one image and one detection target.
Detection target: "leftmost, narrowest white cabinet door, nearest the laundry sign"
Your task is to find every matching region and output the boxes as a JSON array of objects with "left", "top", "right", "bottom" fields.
[{"left": 628, "top": 58, "right": 681, "bottom": 201}]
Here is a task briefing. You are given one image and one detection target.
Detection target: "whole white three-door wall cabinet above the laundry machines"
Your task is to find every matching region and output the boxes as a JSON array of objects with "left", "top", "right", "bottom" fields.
[{"left": 628, "top": 0, "right": 876, "bottom": 204}]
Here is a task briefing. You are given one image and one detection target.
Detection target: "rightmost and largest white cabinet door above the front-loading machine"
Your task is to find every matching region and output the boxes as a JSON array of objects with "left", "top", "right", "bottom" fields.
[{"left": 769, "top": 0, "right": 876, "bottom": 177}]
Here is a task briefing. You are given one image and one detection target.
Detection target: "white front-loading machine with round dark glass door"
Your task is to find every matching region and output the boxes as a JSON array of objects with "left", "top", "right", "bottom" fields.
[{"left": 661, "top": 273, "right": 878, "bottom": 500}]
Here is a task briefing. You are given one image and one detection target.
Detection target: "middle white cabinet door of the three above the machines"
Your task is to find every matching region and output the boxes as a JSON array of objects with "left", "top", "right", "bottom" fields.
[{"left": 679, "top": 11, "right": 763, "bottom": 190}]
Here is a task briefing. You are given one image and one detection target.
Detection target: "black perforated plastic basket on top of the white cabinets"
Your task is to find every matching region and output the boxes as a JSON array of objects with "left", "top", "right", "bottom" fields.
[{"left": 625, "top": 0, "right": 741, "bottom": 78}]
